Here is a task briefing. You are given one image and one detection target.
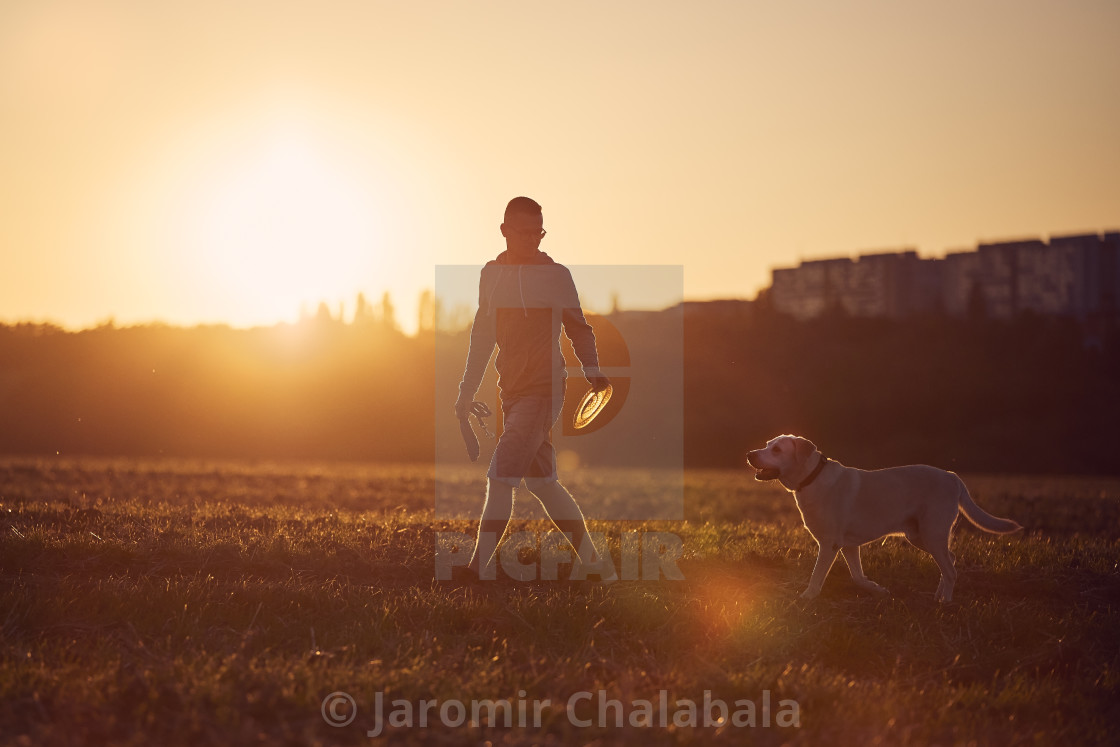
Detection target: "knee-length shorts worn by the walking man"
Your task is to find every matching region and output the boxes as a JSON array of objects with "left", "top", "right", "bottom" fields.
[{"left": 486, "top": 395, "right": 563, "bottom": 487}]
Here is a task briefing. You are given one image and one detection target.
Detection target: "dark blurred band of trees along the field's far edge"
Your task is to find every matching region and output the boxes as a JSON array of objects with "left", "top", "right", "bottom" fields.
[{"left": 0, "top": 304, "right": 1120, "bottom": 474}]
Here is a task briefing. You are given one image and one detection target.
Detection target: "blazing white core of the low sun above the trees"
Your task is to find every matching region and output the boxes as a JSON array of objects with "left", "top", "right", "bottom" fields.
[{"left": 189, "top": 132, "right": 383, "bottom": 325}]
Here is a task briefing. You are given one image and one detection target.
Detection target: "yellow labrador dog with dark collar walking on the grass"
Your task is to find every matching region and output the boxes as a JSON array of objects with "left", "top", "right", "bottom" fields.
[{"left": 747, "top": 436, "right": 1023, "bottom": 601}]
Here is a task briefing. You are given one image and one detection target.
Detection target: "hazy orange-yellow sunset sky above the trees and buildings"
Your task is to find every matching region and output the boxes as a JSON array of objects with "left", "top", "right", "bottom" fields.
[{"left": 0, "top": 0, "right": 1120, "bottom": 328}]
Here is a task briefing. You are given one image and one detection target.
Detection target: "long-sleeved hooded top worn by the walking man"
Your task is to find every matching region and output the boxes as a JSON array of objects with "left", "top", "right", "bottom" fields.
[{"left": 459, "top": 251, "right": 600, "bottom": 402}]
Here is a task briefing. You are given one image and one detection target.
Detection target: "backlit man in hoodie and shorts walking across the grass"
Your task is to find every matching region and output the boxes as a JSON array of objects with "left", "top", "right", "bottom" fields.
[{"left": 455, "top": 197, "right": 614, "bottom": 580}]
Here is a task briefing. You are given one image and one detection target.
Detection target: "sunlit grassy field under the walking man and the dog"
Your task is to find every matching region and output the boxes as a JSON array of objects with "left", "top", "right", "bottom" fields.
[{"left": 0, "top": 459, "right": 1120, "bottom": 745}]
